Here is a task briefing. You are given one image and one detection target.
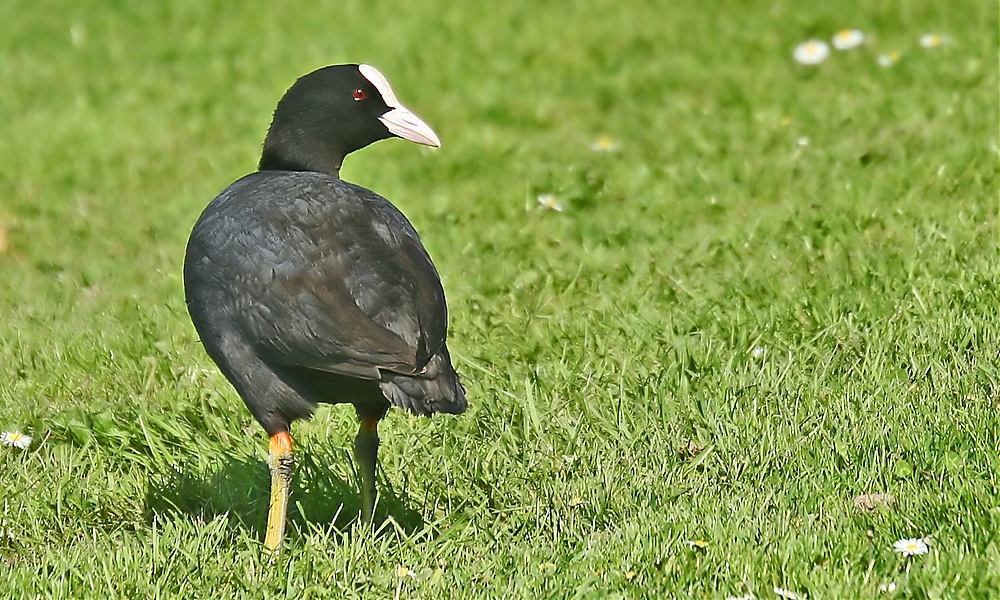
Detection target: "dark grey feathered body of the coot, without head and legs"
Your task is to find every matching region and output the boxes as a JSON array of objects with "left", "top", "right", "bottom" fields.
[{"left": 184, "top": 171, "right": 466, "bottom": 434}]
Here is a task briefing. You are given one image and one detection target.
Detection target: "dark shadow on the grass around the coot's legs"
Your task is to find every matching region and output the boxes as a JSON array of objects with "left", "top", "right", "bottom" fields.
[{"left": 145, "top": 453, "right": 424, "bottom": 540}]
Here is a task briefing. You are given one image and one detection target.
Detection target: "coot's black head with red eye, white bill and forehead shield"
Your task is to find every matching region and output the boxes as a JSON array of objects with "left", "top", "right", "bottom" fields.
[{"left": 260, "top": 65, "right": 441, "bottom": 174}]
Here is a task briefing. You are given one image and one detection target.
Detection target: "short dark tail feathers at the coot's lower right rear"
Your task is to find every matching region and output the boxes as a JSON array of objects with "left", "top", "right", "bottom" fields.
[{"left": 379, "top": 348, "right": 467, "bottom": 416}]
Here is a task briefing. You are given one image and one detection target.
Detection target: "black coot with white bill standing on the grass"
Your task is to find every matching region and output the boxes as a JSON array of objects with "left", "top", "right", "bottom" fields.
[{"left": 184, "top": 64, "right": 466, "bottom": 550}]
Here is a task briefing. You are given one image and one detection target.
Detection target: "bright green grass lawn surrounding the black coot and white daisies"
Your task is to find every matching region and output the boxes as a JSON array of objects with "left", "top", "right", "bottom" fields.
[{"left": 0, "top": 0, "right": 1000, "bottom": 598}]
